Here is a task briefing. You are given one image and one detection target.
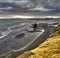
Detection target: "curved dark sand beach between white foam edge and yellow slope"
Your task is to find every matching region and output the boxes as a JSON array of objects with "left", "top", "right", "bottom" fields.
[{"left": 0, "top": 23, "right": 50, "bottom": 58}]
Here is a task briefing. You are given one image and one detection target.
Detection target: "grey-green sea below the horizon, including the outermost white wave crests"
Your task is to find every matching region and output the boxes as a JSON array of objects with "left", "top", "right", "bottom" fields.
[{"left": 0, "top": 19, "right": 60, "bottom": 36}]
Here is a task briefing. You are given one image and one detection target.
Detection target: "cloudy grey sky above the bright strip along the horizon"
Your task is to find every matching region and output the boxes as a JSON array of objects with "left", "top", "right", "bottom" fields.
[{"left": 0, "top": 0, "right": 60, "bottom": 16}]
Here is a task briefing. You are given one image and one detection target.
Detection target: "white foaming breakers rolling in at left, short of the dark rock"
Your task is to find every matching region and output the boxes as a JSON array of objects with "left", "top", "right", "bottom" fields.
[{"left": 0, "top": 23, "right": 28, "bottom": 38}]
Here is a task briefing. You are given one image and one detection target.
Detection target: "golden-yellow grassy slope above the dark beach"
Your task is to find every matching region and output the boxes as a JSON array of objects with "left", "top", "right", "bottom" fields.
[{"left": 17, "top": 26, "right": 60, "bottom": 58}]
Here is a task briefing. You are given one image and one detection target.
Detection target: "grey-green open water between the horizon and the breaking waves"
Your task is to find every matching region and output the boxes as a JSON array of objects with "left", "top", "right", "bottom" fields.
[{"left": 0, "top": 19, "right": 58, "bottom": 30}]
